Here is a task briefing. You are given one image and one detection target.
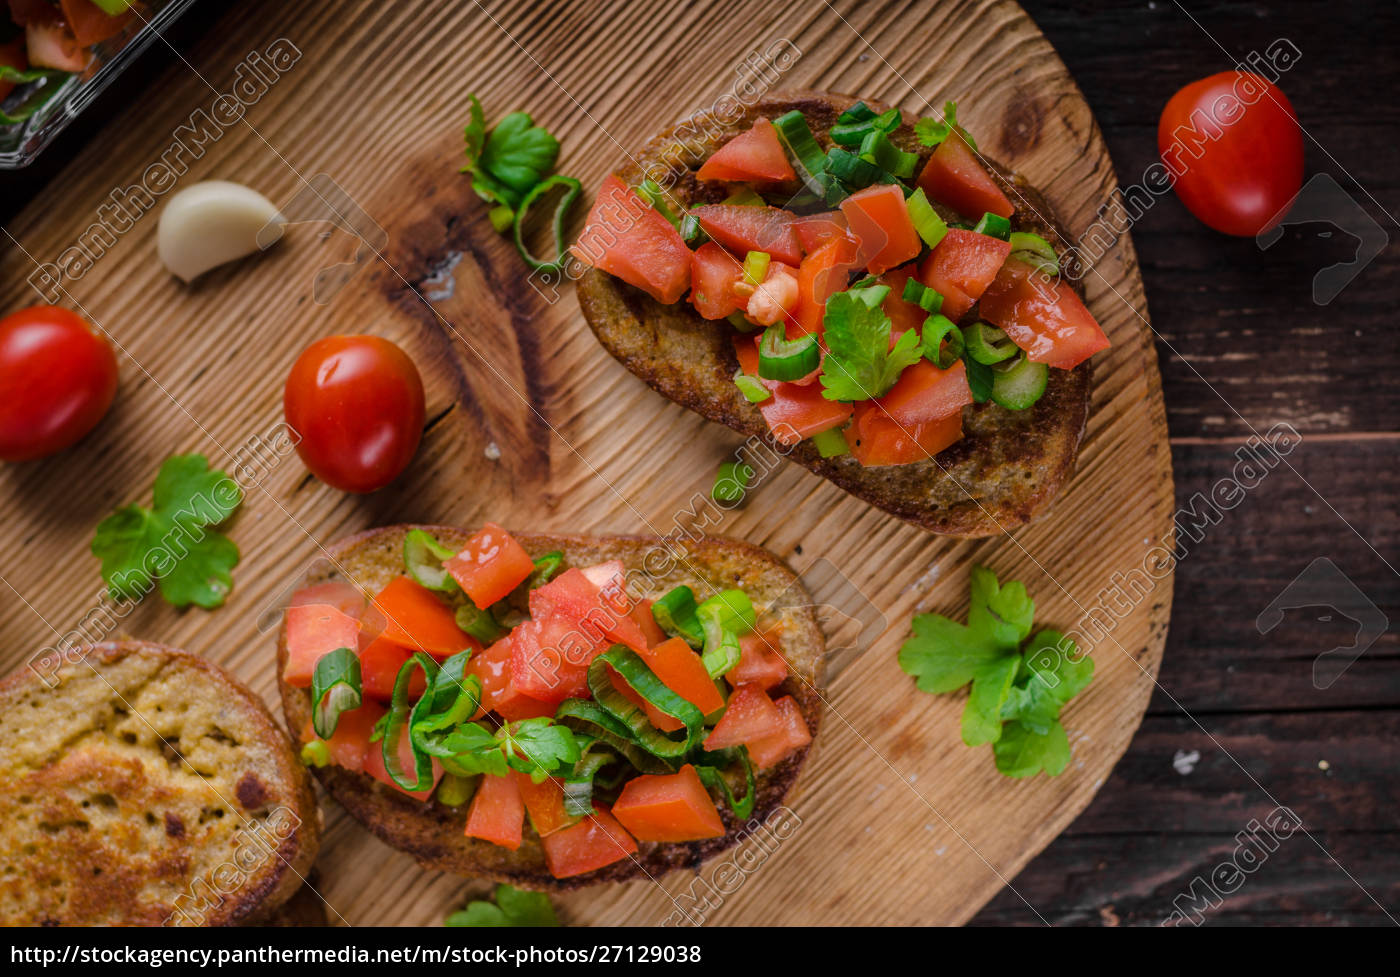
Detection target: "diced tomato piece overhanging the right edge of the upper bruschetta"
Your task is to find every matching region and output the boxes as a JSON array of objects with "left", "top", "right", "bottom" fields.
[{"left": 979, "top": 260, "right": 1109, "bottom": 370}]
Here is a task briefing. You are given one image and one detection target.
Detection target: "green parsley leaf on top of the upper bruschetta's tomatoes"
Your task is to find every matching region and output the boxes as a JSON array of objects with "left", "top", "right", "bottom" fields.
[{"left": 822, "top": 279, "right": 923, "bottom": 400}]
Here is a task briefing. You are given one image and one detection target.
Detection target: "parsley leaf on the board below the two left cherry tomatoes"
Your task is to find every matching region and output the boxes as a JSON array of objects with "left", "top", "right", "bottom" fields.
[{"left": 92, "top": 455, "right": 244, "bottom": 607}]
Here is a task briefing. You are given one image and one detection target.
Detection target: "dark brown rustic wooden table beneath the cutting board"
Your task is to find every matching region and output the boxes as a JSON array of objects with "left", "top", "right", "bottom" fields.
[{"left": 0, "top": 0, "right": 1400, "bottom": 925}]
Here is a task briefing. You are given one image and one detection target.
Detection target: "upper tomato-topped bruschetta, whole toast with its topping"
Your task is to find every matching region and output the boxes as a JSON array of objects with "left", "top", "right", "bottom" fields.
[{"left": 571, "top": 92, "right": 1109, "bottom": 536}]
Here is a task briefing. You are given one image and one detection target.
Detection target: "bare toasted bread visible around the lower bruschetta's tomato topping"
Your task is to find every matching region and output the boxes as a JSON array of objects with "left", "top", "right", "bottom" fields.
[{"left": 277, "top": 525, "right": 826, "bottom": 892}]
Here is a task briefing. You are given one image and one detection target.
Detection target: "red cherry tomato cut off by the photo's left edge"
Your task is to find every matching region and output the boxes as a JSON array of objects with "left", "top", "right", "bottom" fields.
[{"left": 0, "top": 305, "right": 116, "bottom": 462}]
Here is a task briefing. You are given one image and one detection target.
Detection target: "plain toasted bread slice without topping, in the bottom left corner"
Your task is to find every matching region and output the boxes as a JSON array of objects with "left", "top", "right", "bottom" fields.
[{"left": 0, "top": 641, "right": 321, "bottom": 925}]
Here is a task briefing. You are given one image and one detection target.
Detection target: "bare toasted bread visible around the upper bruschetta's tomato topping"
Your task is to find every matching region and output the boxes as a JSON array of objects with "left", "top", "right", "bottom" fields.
[{"left": 578, "top": 91, "right": 1091, "bottom": 536}]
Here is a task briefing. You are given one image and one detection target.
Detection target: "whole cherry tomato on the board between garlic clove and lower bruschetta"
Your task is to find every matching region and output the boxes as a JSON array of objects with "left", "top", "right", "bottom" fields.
[{"left": 283, "top": 336, "right": 424, "bottom": 493}]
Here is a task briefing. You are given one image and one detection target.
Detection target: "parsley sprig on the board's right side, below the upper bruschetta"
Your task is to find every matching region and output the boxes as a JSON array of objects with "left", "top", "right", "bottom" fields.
[{"left": 899, "top": 567, "right": 1093, "bottom": 777}]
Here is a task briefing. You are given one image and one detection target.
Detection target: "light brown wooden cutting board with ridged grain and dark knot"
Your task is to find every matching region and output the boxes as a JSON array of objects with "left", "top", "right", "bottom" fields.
[{"left": 0, "top": 0, "right": 1173, "bottom": 924}]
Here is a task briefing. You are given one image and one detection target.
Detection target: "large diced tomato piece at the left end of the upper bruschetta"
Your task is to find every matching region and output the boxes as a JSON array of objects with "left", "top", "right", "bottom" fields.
[{"left": 570, "top": 175, "right": 690, "bottom": 305}]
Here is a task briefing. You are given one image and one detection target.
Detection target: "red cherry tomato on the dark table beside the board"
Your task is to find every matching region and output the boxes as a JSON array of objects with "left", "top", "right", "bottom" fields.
[{"left": 1156, "top": 71, "right": 1303, "bottom": 237}]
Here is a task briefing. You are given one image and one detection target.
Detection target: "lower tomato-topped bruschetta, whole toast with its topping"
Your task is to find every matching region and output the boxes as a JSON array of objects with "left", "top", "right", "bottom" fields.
[{"left": 279, "top": 523, "right": 825, "bottom": 890}]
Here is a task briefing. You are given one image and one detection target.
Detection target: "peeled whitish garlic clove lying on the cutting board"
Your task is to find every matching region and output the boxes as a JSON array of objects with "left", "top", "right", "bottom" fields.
[{"left": 157, "top": 179, "right": 284, "bottom": 281}]
